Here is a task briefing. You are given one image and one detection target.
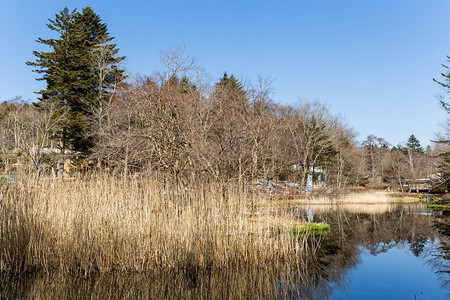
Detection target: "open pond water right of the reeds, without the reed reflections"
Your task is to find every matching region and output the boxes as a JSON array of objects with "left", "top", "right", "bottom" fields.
[{"left": 297, "top": 203, "right": 450, "bottom": 299}]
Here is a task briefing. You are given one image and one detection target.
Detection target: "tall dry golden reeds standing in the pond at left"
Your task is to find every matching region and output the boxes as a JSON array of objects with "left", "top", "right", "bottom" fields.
[{"left": 0, "top": 176, "right": 308, "bottom": 274}]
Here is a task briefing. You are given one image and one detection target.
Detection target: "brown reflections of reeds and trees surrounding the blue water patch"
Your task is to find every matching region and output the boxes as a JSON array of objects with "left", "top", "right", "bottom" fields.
[{"left": 0, "top": 204, "right": 450, "bottom": 299}]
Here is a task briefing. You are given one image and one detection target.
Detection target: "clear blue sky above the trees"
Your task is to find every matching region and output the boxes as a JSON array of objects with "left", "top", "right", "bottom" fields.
[{"left": 0, "top": 0, "right": 450, "bottom": 145}]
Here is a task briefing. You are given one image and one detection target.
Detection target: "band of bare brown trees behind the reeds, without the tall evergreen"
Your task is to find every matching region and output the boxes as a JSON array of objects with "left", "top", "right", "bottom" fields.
[{"left": 0, "top": 74, "right": 442, "bottom": 188}]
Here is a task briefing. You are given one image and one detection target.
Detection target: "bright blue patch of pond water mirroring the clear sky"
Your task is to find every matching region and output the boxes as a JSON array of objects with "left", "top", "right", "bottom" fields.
[{"left": 333, "top": 241, "right": 446, "bottom": 299}]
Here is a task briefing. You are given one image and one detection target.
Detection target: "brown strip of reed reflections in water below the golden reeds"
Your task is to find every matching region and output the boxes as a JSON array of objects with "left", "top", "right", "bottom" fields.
[{"left": 1, "top": 265, "right": 344, "bottom": 299}]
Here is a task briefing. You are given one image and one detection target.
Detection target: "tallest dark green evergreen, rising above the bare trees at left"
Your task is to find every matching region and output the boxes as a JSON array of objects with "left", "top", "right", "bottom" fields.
[{"left": 27, "top": 7, "right": 124, "bottom": 151}]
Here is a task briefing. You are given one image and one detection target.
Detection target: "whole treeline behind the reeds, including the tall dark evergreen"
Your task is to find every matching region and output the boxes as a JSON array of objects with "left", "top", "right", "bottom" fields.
[{"left": 0, "top": 7, "right": 448, "bottom": 188}]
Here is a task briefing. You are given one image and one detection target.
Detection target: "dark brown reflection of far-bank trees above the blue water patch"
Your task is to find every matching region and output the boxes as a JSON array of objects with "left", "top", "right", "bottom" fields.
[{"left": 320, "top": 204, "right": 450, "bottom": 290}]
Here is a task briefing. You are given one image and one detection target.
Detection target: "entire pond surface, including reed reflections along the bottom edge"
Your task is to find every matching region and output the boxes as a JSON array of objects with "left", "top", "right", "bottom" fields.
[{"left": 0, "top": 204, "right": 450, "bottom": 299}]
